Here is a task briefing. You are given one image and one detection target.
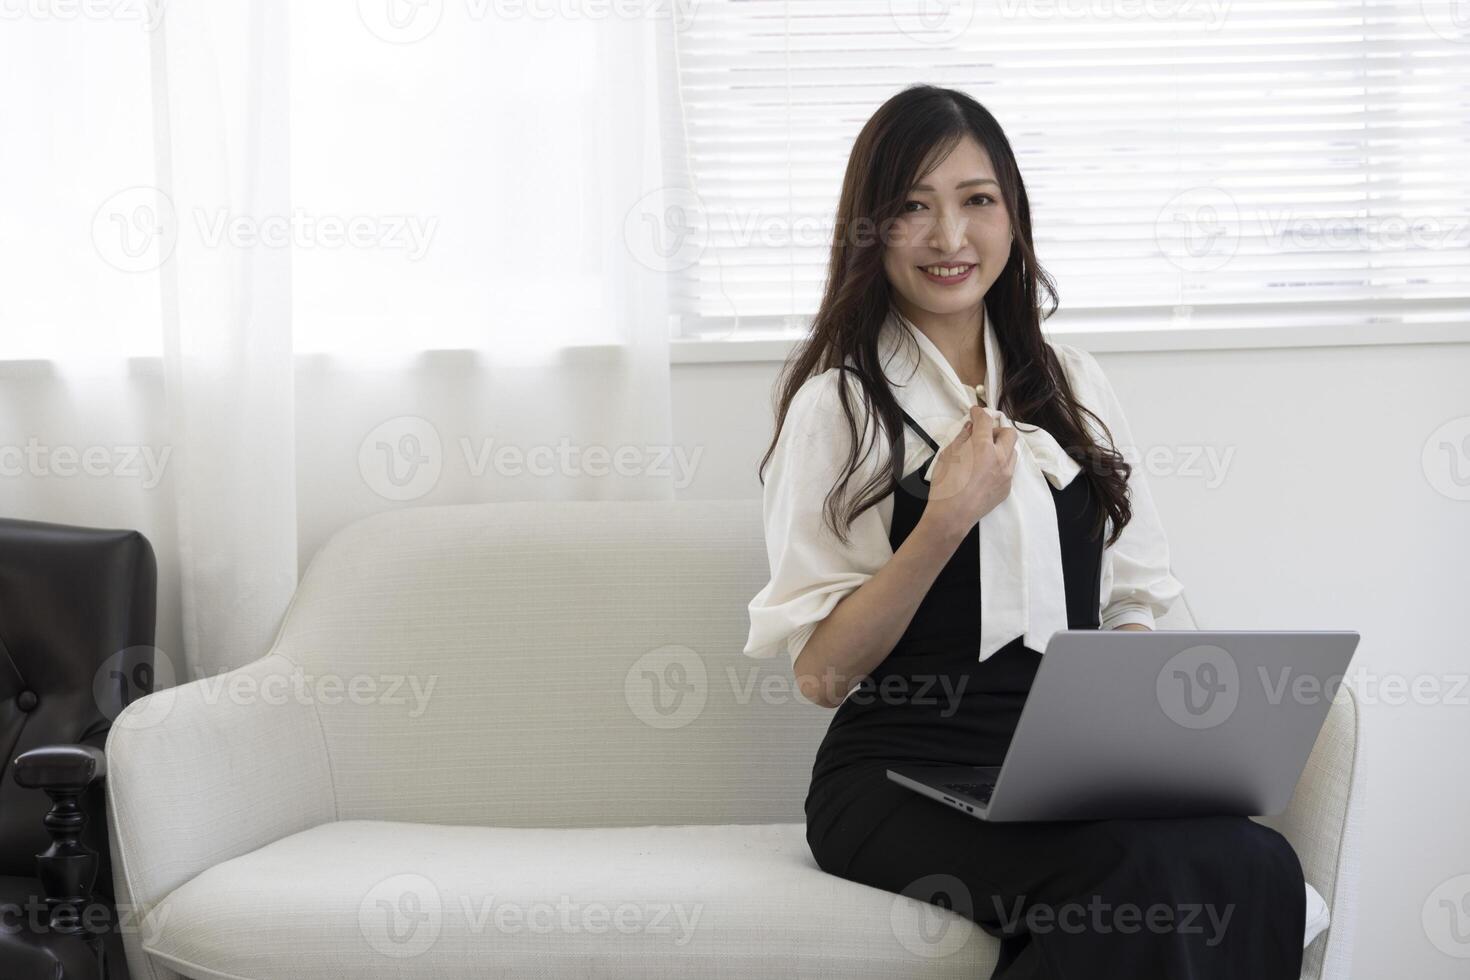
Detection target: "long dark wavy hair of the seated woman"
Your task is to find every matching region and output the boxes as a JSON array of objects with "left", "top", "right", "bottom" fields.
[{"left": 759, "top": 85, "right": 1132, "bottom": 545}]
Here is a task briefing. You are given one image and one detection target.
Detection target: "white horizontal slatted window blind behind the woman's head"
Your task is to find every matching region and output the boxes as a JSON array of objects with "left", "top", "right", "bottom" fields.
[{"left": 673, "top": 0, "right": 1470, "bottom": 336}]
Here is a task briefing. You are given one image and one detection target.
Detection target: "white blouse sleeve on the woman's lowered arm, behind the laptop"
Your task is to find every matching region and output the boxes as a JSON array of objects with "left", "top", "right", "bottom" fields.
[{"left": 1058, "top": 345, "right": 1183, "bottom": 629}]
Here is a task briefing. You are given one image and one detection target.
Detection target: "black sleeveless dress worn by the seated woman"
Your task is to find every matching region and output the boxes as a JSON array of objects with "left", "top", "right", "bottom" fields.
[{"left": 806, "top": 413, "right": 1307, "bottom": 980}]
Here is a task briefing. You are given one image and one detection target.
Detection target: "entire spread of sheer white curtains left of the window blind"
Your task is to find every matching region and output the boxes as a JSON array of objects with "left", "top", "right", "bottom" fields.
[{"left": 0, "top": 0, "right": 681, "bottom": 683}]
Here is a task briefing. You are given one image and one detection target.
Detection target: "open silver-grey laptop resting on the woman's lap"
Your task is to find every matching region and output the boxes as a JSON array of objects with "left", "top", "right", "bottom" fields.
[{"left": 888, "top": 630, "right": 1358, "bottom": 821}]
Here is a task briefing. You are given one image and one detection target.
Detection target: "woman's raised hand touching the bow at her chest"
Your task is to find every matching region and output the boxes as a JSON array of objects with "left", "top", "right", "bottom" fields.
[{"left": 919, "top": 406, "right": 1019, "bottom": 539}]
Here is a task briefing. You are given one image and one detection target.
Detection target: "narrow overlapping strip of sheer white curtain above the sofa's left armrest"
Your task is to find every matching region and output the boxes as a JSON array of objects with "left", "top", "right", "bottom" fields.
[{"left": 151, "top": 0, "right": 297, "bottom": 687}]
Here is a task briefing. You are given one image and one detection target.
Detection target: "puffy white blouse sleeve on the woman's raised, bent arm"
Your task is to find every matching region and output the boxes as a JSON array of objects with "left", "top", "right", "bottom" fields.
[{"left": 742, "top": 367, "right": 892, "bottom": 664}]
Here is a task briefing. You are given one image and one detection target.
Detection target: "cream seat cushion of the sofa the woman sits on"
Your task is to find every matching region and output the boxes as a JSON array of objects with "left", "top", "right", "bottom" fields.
[{"left": 144, "top": 820, "right": 1334, "bottom": 980}]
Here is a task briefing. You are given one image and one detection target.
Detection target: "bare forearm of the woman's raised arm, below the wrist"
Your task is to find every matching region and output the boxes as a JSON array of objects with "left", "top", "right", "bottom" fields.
[{"left": 792, "top": 517, "right": 964, "bottom": 708}]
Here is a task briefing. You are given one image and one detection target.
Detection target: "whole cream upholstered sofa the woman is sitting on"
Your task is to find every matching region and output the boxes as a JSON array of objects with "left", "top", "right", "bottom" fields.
[{"left": 107, "top": 500, "right": 1361, "bottom": 980}]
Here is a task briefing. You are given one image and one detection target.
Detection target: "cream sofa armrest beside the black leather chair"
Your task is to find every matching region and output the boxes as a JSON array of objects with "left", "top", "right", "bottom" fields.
[{"left": 107, "top": 654, "right": 337, "bottom": 977}]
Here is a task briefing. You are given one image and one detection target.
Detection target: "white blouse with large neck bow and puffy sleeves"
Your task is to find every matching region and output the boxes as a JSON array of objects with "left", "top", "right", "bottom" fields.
[{"left": 742, "top": 309, "right": 1183, "bottom": 663}]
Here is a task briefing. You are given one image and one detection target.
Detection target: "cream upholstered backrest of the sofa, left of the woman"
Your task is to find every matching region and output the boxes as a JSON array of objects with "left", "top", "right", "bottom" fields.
[{"left": 272, "top": 500, "right": 832, "bottom": 827}]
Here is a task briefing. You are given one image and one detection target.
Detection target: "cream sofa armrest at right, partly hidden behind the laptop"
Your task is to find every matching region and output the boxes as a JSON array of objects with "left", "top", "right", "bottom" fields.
[{"left": 1260, "top": 683, "right": 1364, "bottom": 980}]
